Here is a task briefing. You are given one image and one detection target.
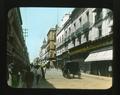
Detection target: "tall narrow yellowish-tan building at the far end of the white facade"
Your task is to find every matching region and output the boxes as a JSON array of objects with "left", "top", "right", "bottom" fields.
[{"left": 47, "top": 28, "right": 56, "bottom": 66}]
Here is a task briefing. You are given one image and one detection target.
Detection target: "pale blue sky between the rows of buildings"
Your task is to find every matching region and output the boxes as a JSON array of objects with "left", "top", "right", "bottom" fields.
[{"left": 20, "top": 7, "right": 74, "bottom": 62}]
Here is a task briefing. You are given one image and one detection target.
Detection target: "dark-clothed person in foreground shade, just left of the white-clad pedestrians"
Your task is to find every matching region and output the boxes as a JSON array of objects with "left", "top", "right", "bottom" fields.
[{"left": 25, "top": 67, "right": 34, "bottom": 88}]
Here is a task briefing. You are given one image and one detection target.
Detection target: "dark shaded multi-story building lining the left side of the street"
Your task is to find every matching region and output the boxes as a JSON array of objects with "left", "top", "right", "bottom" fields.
[{"left": 7, "top": 8, "right": 30, "bottom": 73}]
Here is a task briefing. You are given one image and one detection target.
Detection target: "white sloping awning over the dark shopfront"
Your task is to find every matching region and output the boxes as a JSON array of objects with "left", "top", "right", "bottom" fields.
[{"left": 85, "top": 50, "right": 113, "bottom": 62}]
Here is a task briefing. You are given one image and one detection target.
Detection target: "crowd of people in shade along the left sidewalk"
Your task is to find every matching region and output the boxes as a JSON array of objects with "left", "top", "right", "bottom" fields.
[{"left": 7, "top": 63, "right": 46, "bottom": 88}]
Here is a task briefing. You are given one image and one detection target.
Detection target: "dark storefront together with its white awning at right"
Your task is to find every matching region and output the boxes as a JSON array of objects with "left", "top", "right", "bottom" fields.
[{"left": 85, "top": 47, "right": 113, "bottom": 76}]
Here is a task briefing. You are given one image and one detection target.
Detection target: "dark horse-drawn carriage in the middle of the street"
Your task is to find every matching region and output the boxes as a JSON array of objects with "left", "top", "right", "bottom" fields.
[{"left": 62, "top": 61, "right": 81, "bottom": 78}]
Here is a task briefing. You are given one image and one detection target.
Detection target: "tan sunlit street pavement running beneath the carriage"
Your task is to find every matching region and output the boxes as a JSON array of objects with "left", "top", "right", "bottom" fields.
[{"left": 33, "top": 69, "right": 112, "bottom": 89}]
